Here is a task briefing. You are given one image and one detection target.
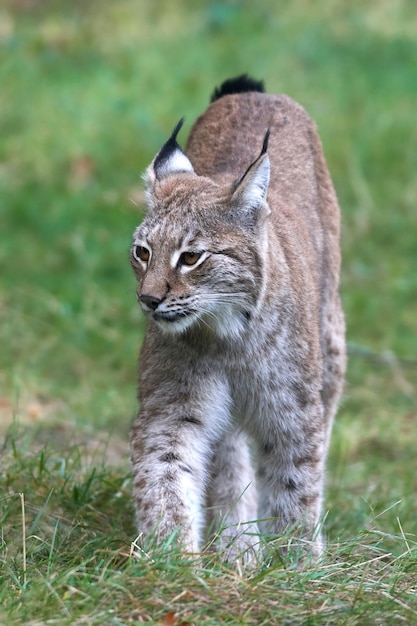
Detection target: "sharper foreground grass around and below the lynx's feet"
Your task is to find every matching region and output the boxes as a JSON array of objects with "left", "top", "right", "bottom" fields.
[{"left": 0, "top": 433, "right": 417, "bottom": 625}]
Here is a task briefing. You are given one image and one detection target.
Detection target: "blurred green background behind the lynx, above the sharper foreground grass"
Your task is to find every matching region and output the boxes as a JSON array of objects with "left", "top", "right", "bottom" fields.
[{"left": 0, "top": 0, "right": 417, "bottom": 520}]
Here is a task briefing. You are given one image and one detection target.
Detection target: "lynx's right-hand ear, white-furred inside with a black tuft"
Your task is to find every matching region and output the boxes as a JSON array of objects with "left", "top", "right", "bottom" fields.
[{"left": 232, "top": 130, "right": 270, "bottom": 223}]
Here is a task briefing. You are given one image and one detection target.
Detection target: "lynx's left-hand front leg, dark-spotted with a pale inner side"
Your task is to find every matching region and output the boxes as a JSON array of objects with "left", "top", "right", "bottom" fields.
[{"left": 131, "top": 378, "right": 228, "bottom": 552}]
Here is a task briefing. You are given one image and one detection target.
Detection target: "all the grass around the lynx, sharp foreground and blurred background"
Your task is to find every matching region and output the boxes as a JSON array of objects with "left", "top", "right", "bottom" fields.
[{"left": 0, "top": 0, "right": 417, "bottom": 626}]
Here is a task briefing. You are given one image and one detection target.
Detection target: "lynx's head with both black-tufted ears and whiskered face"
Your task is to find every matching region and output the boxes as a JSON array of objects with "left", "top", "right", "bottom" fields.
[{"left": 131, "top": 120, "right": 270, "bottom": 337}]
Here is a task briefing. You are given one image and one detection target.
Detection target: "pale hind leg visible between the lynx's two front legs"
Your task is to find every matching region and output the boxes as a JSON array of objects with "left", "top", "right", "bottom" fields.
[{"left": 207, "top": 432, "right": 259, "bottom": 563}]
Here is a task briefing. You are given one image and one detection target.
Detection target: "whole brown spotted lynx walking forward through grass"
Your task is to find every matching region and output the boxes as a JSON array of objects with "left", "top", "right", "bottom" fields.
[{"left": 131, "top": 76, "right": 345, "bottom": 556}]
